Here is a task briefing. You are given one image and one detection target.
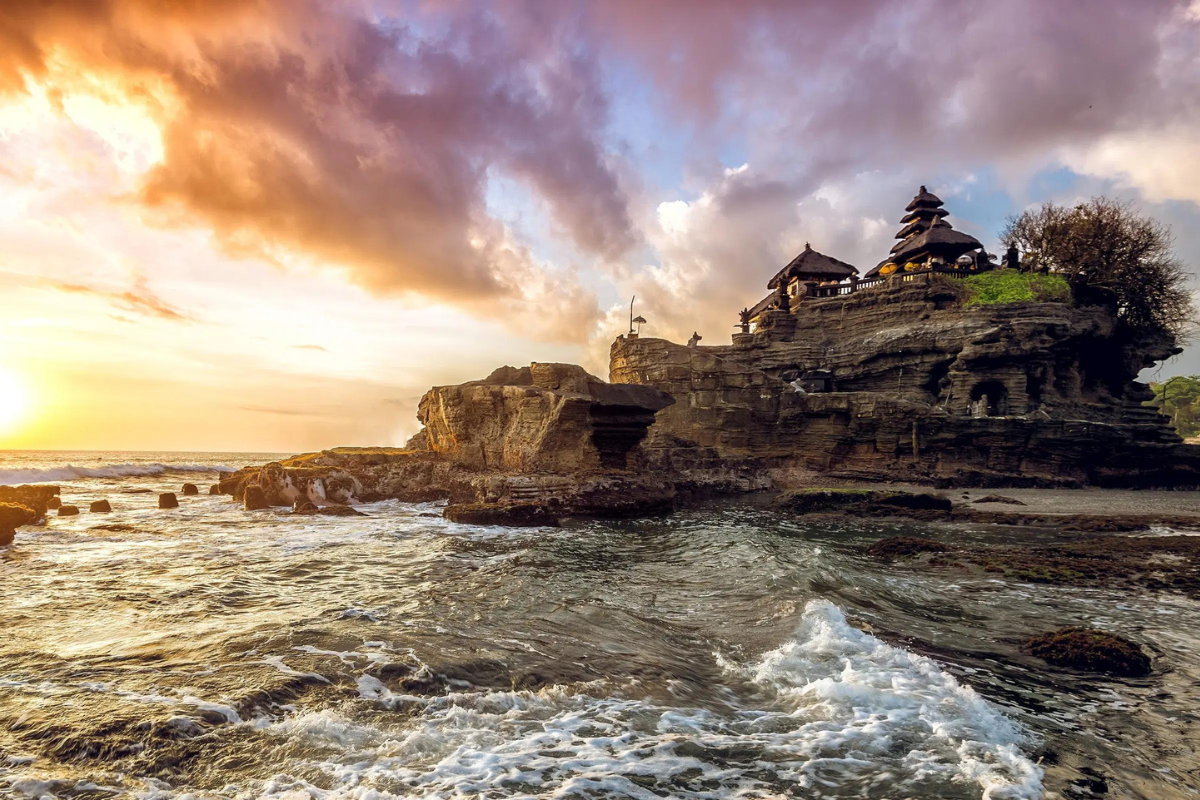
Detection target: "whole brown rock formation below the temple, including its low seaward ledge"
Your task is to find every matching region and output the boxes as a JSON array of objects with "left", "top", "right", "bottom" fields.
[{"left": 220, "top": 271, "right": 1200, "bottom": 524}]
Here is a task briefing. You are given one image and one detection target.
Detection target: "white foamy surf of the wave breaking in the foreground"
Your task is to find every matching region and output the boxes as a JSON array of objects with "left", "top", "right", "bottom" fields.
[{"left": 253, "top": 601, "right": 1042, "bottom": 800}]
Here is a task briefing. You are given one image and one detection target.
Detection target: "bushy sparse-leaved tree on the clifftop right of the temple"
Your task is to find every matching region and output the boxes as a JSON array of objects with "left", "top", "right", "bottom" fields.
[{"left": 1000, "top": 197, "right": 1195, "bottom": 339}]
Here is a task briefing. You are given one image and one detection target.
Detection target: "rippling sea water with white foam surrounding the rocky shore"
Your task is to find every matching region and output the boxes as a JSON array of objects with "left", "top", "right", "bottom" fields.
[{"left": 0, "top": 452, "right": 1200, "bottom": 800}]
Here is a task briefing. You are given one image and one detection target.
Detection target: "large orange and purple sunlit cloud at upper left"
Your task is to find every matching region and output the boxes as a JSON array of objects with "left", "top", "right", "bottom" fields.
[{"left": 0, "top": 0, "right": 637, "bottom": 340}]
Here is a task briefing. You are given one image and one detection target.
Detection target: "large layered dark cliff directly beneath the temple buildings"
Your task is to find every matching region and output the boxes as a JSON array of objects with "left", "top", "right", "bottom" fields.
[{"left": 611, "top": 284, "right": 1200, "bottom": 486}]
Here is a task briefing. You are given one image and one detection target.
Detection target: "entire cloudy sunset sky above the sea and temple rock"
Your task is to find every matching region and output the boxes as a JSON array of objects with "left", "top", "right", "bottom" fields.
[{"left": 0, "top": 0, "right": 1200, "bottom": 452}]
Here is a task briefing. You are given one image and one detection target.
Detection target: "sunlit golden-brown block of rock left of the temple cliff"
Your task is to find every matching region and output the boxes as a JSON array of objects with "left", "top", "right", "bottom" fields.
[{"left": 414, "top": 363, "right": 673, "bottom": 473}]
